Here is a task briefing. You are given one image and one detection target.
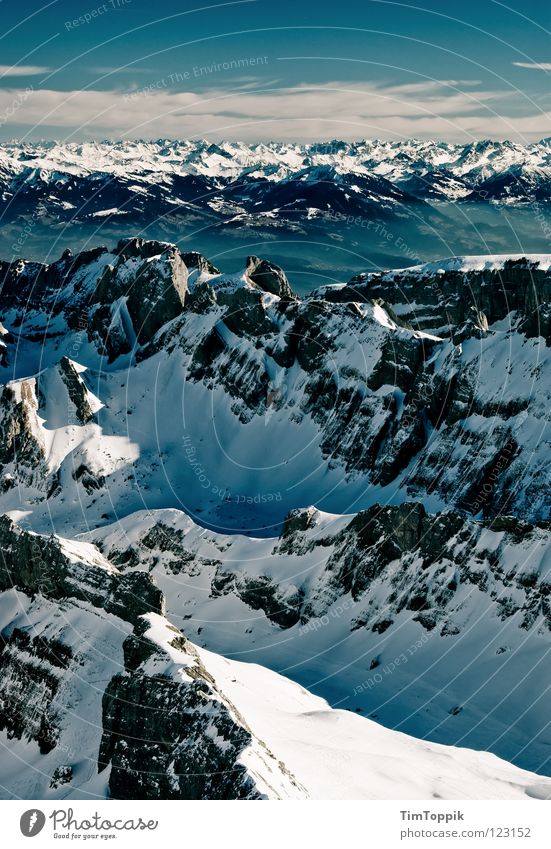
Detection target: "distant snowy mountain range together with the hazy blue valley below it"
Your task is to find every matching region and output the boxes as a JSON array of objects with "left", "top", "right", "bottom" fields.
[{"left": 0, "top": 140, "right": 551, "bottom": 295}]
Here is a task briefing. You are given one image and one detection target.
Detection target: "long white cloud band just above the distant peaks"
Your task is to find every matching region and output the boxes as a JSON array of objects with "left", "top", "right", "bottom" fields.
[{"left": 0, "top": 79, "right": 551, "bottom": 141}]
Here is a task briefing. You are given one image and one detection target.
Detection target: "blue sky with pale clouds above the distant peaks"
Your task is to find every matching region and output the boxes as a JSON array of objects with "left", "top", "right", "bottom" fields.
[{"left": 0, "top": 0, "right": 551, "bottom": 142}]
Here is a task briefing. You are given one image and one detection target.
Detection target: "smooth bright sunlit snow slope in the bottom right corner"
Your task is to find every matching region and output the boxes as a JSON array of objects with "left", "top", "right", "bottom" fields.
[{"left": 199, "top": 649, "right": 551, "bottom": 799}]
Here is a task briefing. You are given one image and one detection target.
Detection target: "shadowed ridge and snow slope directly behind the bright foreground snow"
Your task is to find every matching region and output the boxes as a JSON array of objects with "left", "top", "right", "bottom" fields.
[{"left": 91, "top": 503, "right": 551, "bottom": 772}]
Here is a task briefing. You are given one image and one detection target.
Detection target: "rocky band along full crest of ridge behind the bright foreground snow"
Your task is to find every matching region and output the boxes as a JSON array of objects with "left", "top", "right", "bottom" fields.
[{"left": 95, "top": 502, "right": 551, "bottom": 633}]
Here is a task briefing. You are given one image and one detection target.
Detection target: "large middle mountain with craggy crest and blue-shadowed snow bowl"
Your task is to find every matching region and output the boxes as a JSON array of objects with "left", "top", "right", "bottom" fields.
[{"left": 0, "top": 240, "right": 551, "bottom": 534}]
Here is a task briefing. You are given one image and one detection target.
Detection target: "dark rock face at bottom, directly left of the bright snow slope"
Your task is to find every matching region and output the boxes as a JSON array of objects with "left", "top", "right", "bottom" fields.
[{"left": 99, "top": 627, "right": 259, "bottom": 799}]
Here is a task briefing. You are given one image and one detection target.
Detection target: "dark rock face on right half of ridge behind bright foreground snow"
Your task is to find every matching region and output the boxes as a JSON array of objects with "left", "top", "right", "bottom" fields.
[{"left": 276, "top": 502, "right": 551, "bottom": 635}]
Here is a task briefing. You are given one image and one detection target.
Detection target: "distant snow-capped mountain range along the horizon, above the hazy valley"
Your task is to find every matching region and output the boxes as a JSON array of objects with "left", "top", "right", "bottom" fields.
[{"left": 0, "top": 139, "right": 551, "bottom": 232}]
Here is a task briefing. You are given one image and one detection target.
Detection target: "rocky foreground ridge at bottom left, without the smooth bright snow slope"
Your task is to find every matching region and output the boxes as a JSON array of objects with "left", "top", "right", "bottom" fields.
[{"left": 0, "top": 518, "right": 295, "bottom": 799}]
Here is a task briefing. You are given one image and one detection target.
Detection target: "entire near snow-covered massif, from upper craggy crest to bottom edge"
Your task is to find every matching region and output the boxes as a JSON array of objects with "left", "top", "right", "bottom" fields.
[{"left": 0, "top": 237, "right": 551, "bottom": 798}]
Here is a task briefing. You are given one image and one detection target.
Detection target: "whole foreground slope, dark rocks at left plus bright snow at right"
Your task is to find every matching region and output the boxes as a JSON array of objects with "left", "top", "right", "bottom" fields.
[{"left": 0, "top": 519, "right": 551, "bottom": 799}]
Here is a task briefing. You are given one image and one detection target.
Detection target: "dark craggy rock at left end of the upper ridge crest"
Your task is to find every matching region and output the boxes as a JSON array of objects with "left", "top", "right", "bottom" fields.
[{"left": 0, "top": 239, "right": 188, "bottom": 361}]
